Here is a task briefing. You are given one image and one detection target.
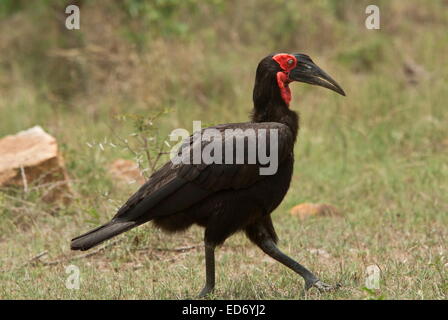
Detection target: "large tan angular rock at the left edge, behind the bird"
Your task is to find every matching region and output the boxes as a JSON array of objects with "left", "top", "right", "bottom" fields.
[{"left": 0, "top": 126, "right": 70, "bottom": 202}]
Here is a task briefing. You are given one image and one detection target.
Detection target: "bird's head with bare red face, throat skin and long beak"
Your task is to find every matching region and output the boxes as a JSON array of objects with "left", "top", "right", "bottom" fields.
[{"left": 257, "top": 53, "right": 345, "bottom": 105}]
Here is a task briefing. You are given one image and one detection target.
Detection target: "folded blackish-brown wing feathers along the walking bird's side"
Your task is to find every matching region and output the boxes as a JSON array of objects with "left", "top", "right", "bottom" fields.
[{"left": 114, "top": 122, "right": 294, "bottom": 221}]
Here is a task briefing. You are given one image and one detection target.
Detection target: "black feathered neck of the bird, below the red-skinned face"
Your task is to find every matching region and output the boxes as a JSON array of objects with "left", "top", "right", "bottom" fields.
[{"left": 252, "top": 75, "right": 299, "bottom": 142}]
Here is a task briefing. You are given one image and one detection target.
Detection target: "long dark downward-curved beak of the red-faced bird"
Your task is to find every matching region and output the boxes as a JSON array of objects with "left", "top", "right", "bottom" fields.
[{"left": 289, "top": 54, "right": 345, "bottom": 96}]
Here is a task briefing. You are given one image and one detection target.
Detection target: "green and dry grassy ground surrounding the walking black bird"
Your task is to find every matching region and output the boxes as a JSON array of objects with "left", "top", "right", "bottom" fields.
[{"left": 0, "top": 0, "right": 448, "bottom": 299}]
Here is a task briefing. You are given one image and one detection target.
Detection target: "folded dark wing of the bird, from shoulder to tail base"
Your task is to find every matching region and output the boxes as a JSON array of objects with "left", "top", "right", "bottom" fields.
[{"left": 114, "top": 122, "right": 294, "bottom": 220}]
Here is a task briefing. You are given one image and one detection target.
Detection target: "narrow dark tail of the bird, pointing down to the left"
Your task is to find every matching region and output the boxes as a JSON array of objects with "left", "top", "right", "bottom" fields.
[{"left": 70, "top": 220, "right": 139, "bottom": 251}]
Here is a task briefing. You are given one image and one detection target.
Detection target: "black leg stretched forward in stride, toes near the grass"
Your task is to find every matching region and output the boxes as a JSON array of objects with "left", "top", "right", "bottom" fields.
[{"left": 246, "top": 219, "right": 333, "bottom": 290}]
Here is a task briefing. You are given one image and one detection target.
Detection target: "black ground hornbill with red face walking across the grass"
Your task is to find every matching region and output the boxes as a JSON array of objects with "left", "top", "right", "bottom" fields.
[{"left": 71, "top": 53, "right": 345, "bottom": 296}]
